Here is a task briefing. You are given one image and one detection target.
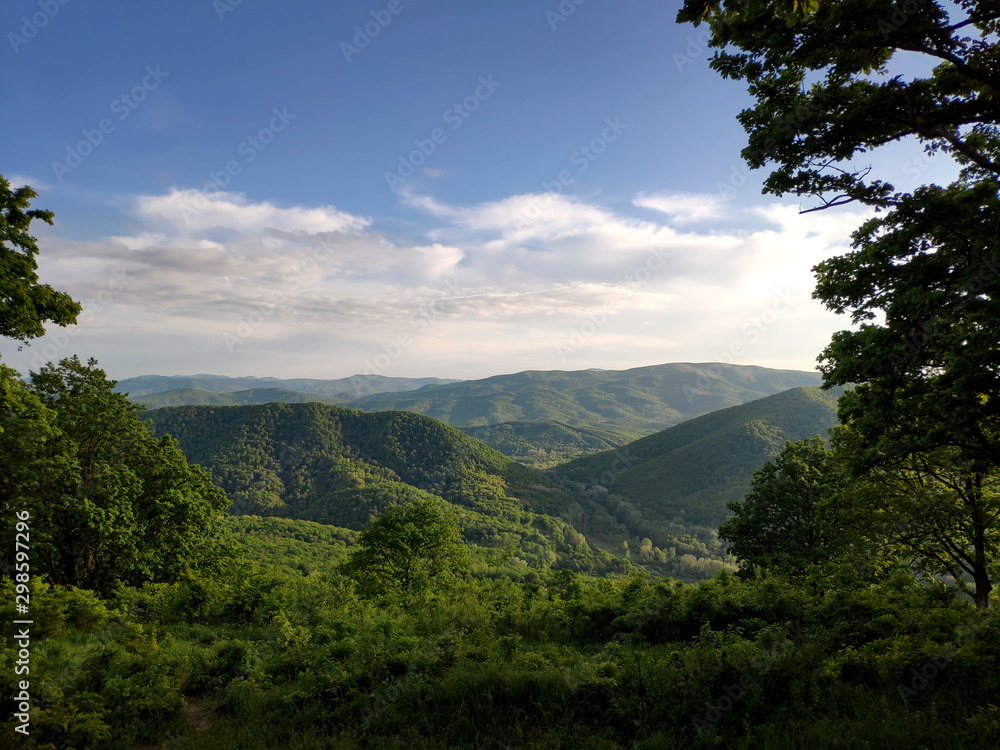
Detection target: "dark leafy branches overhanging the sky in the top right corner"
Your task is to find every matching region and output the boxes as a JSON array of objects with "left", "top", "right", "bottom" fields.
[{"left": 678, "top": 0, "right": 1000, "bottom": 212}]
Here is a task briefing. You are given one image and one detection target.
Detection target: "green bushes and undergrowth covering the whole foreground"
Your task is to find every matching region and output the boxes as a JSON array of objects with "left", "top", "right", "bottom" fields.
[{"left": 0, "top": 548, "right": 1000, "bottom": 750}]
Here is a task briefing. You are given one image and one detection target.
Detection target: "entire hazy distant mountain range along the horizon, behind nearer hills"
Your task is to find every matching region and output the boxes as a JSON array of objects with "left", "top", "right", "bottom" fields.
[{"left": 129, "top": 363, "right": 820, "bottom": 468}]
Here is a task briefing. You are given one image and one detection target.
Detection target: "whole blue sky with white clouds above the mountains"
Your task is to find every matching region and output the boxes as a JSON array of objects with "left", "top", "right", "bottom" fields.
[{"left": 0, "top": 0, "right": 947, "bottom": 378}]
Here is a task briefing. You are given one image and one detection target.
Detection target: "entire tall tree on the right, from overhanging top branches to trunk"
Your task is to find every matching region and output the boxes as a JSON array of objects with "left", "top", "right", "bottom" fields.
[{"left": 679, "top": 0, "right": 1000, "bottom": 607}]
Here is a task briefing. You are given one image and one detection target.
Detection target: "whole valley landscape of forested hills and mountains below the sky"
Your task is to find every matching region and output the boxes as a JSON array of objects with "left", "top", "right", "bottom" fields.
[{"left": 141, "top": 365, "right": 836, "bottom": 581}]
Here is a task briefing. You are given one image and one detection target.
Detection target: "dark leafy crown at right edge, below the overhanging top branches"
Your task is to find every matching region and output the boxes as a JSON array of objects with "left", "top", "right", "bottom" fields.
[{"left": 815, "top": 183, "right": 1000, "bottom": 468}]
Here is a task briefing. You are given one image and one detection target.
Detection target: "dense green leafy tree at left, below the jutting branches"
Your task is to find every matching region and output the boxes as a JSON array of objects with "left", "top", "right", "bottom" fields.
[{"left": 0, "top": 357, "right": 228, "bottom": 594}]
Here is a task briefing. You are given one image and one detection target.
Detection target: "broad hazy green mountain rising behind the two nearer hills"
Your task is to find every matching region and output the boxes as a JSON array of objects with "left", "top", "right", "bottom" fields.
[{"left": 351, "top": 362, "right": 821, "bottom": 468}]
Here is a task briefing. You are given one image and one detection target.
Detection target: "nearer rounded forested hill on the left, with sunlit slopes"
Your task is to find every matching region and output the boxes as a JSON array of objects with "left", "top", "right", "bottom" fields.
[{"left": 150, "top": 403, "right": 621, "bottom": 570}]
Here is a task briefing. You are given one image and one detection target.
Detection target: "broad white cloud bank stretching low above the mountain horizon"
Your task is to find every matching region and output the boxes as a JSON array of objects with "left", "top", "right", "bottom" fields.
[{"left": 4, "top": 189, "right": 862, "bottom": 377}]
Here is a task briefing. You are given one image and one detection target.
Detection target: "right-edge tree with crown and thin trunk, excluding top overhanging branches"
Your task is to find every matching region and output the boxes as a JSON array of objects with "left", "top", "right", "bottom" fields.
[{"left": 814, "top": 180, "right": 1000, "bottom": 607}]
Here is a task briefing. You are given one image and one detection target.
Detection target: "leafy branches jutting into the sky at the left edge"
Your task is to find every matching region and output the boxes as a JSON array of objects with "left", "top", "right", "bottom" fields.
[{"left": 0, "top": 175, "right": 81, "bottom": 342}]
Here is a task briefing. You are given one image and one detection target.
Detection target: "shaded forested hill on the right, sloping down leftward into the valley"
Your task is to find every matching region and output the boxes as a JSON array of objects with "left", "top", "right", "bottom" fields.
[{"left": 553, "top": 387, "right": 843, "bottom": 528}]
